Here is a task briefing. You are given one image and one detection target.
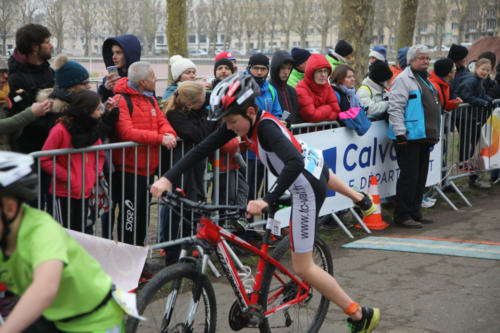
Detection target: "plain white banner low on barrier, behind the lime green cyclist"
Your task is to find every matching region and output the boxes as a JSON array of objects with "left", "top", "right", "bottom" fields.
[{"left": 66, "top": 229, "right": 148, "bottom": 291}]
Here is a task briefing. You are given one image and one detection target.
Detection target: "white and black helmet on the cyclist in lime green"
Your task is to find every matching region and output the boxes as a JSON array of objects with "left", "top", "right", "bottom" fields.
[{"left": 0, "top": 151, "right": 38, "bottom": 201}]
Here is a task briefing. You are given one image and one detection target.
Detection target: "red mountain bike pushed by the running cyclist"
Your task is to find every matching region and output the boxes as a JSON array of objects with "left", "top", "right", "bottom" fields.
[{"left": 126, "top": 192, "right": 333, "bottom": 333}]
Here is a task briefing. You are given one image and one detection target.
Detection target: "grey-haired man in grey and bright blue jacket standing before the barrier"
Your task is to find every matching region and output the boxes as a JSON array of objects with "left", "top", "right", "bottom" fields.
[{"left": 388, "top": 44, "right": 440, "bottom": 228}]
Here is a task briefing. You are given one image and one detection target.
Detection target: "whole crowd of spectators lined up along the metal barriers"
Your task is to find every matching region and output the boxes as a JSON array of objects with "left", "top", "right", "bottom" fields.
[{"left": 0, "top": 24, "right": 500, "bottom": 246}]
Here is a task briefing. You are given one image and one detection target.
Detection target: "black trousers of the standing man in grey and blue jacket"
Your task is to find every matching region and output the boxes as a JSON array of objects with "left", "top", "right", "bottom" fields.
[{"left": 394, "top": 141, "right": 432, "bottom": 223}]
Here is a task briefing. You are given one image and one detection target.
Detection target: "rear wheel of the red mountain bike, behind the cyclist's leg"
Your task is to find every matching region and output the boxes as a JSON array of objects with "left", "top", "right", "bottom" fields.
[{"left": 259, "top": 235, "right": 333, "bottom": 333}]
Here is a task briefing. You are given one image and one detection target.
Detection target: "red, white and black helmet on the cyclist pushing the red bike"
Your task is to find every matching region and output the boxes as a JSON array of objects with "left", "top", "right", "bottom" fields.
[{"left": 208, "top": 73, "right": 260, "bottom": 121}]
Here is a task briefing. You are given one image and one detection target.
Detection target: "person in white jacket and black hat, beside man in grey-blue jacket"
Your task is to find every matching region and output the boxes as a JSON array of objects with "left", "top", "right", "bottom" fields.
[{"left": 356, "top": 60, "right": 392, "bottom": 120}]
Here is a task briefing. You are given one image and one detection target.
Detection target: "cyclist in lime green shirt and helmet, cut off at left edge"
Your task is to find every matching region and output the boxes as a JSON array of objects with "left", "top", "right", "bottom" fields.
[{"left": 0, "top": 152, "right": 125, "bottom": 333}]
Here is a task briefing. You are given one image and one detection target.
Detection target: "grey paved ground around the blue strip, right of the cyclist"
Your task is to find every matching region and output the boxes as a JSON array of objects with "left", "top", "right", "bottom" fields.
[{"left": 208, "top": 179, "right": 500, "bottom": 333}]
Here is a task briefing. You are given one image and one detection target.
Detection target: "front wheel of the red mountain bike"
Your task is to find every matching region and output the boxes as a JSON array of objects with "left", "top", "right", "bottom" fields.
[{"left": 126, "top": 263, "right": 217, "bottom": 333}]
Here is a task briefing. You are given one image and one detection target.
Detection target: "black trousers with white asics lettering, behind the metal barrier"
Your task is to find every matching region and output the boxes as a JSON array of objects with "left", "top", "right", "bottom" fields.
[{"left": 111, "top": 171, "right": 153, "bottom": 246}]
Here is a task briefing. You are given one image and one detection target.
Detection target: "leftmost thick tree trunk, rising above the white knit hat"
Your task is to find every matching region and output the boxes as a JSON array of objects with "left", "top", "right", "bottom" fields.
[{"left": 166, "top": 0, "right": 188, "bottom": 84}]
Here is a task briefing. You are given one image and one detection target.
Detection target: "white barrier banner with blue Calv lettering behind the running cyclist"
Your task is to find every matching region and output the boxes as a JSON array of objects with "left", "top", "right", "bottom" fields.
[{"left": 269, "top": 120, "right": 441, "bottom": 221}]
